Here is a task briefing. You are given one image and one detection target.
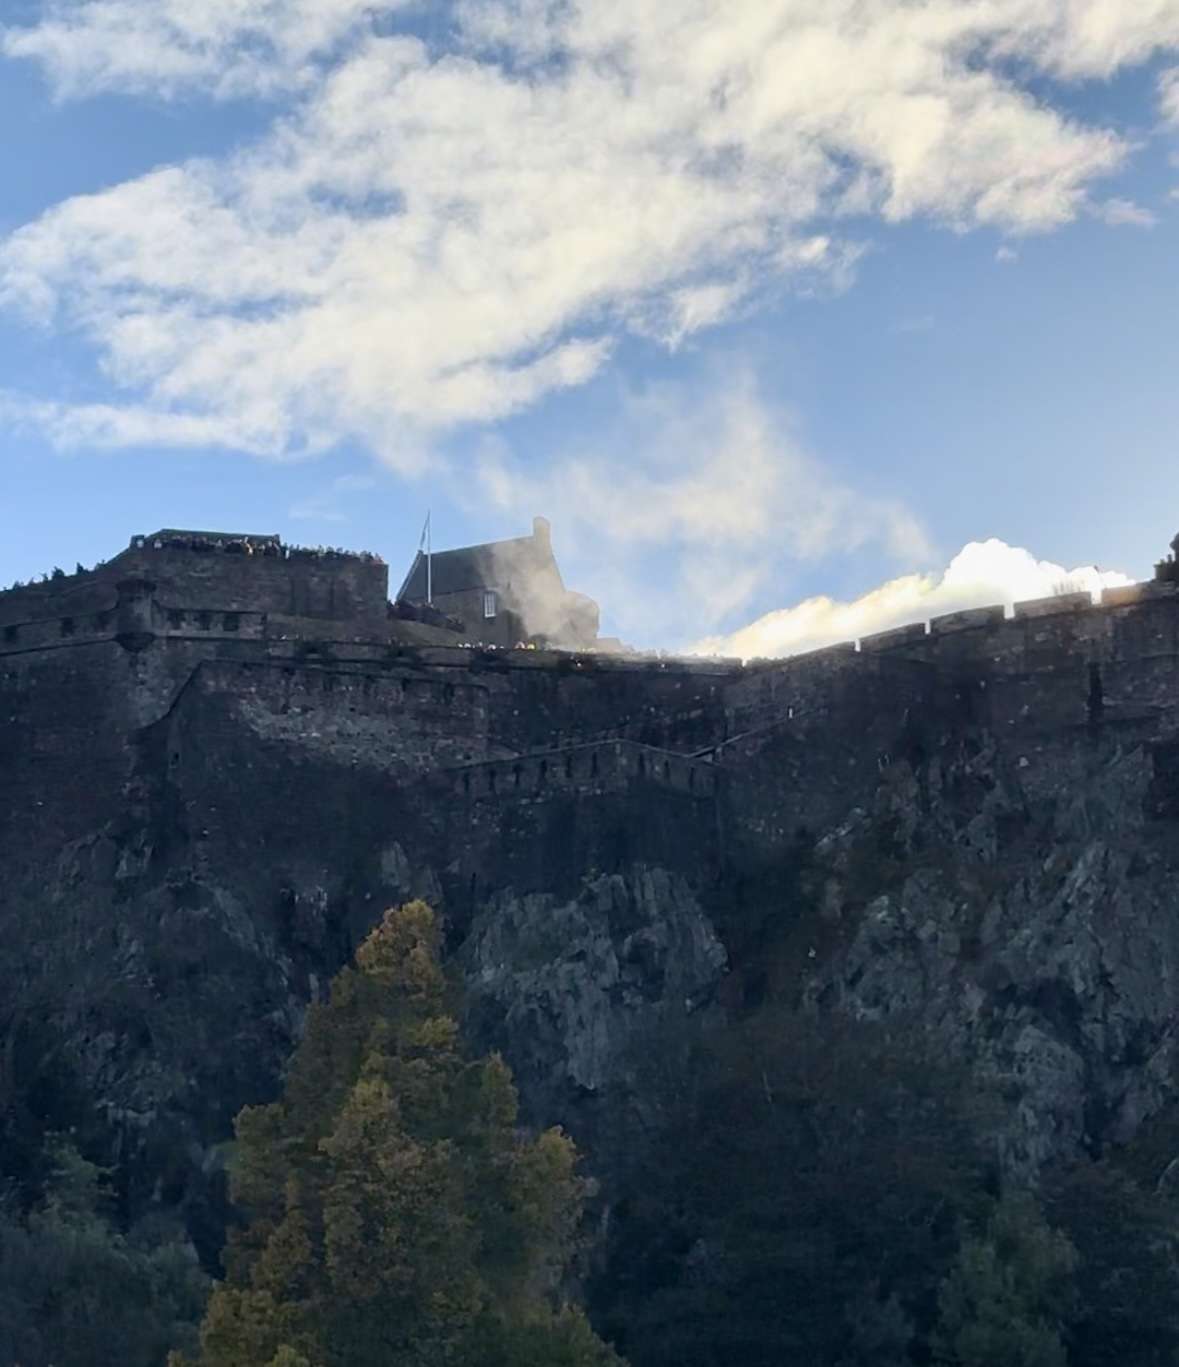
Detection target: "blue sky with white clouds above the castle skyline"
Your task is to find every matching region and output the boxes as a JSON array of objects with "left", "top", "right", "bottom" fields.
[{"left": 0, "top": 0, "right": 1179, "bottom": 651}]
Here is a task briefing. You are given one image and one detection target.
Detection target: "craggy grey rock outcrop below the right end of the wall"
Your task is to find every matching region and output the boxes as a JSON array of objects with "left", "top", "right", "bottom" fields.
[{"left": 804, "top": 744, "right": 1179, "bottom": 1172}]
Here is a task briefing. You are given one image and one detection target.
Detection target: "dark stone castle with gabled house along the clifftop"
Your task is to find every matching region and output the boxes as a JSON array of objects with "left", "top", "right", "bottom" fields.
[{"left": 0, "top": 519, "right": 1179, "bottom": 863}]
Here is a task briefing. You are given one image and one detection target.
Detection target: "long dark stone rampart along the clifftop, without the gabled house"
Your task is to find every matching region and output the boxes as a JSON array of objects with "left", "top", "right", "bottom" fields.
[{"left": 0, "top": 530, "right": 1179, "bottom": 797}]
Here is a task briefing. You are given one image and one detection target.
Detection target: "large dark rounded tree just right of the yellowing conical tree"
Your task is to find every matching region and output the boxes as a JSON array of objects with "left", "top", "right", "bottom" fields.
[{"left": 592, "top": 1005, "right": 989, "bottom": 1367}]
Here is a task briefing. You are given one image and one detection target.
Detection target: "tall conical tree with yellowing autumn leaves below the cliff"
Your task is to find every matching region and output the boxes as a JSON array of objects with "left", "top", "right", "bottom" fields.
[{"left": 175, "top": 902, "right": 618, "bottom": 1367}]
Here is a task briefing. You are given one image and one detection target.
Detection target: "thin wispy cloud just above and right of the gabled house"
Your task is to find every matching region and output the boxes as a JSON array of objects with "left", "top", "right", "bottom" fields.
[{"left": 458, "top": 369, "right": 930, "bottom": 642}]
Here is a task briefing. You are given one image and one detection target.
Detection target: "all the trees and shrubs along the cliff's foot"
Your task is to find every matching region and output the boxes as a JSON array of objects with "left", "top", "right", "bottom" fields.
[{"left": 0, "top": 904, "right": 1179, "bottom": 1367}]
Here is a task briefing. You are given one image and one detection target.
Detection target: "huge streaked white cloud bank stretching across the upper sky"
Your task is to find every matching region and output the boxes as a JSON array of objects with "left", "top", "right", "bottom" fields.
[{"left": 0, "top": 0, "right": 1179, "bottom": 469}]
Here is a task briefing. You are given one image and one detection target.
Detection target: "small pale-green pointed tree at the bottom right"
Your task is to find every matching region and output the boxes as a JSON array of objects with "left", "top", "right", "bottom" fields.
[{"left": 934, "top": 1193, "right": 1076, "bottom": 1367}]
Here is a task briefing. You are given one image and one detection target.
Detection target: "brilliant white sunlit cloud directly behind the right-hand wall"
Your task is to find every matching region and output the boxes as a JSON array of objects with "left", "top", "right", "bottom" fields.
[{"left": 695, "top": 539, "right": 1132, "bottom": 659}]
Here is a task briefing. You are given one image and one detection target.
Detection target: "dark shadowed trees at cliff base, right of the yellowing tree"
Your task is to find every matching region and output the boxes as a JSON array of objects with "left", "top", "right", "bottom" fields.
[{"left": 591, "top": 1005, "right": 1179, "bottom": 1367}]
